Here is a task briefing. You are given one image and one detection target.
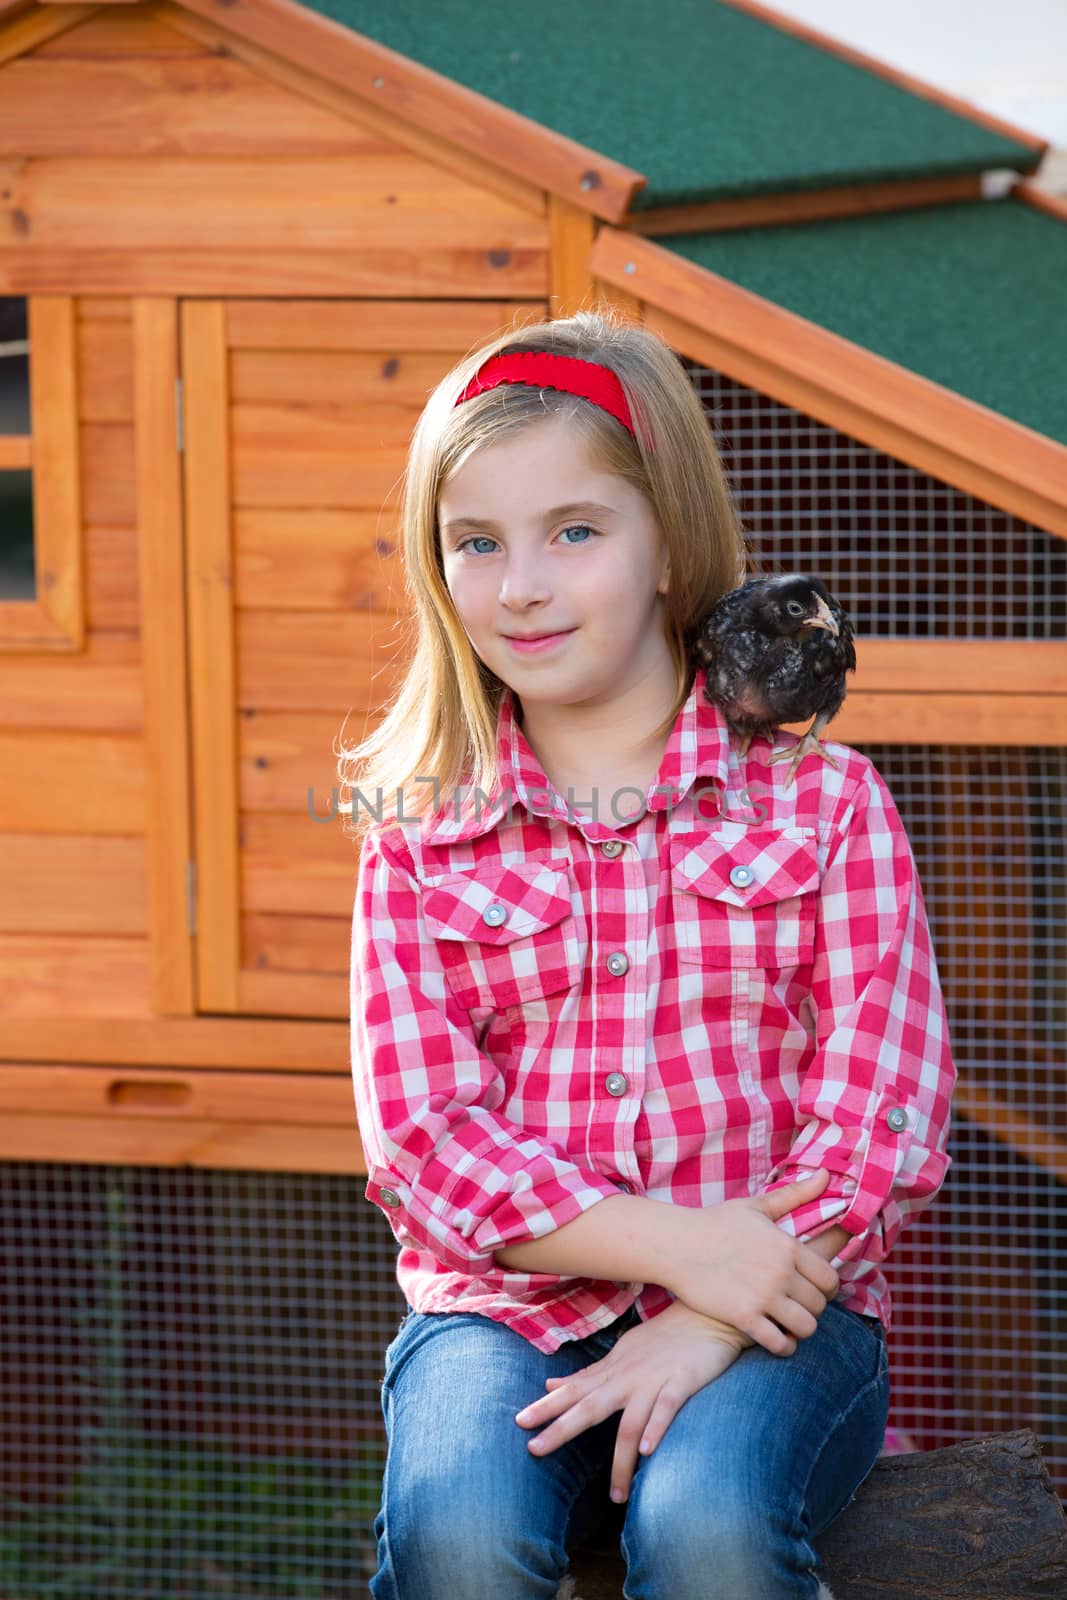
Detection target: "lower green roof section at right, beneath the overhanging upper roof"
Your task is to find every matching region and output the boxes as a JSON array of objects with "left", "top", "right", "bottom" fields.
[{"left": 656, "top": 197, "right": 1067, "bottom": 445}]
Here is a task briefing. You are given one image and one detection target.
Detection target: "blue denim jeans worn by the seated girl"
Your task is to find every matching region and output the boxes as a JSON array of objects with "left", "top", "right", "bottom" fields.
[{"left": 370, "top": 1301, "right": 889, "bottom": 1600}]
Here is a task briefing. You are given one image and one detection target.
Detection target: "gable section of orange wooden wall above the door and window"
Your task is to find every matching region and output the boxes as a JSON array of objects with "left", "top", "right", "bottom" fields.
[{"left": 0, "top": 5, "right": 549, "bottom": 299}]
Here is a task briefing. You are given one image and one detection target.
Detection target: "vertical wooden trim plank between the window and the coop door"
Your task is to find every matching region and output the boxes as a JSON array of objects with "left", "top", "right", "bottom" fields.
[{"left": 133, "top": 299, "right": 195, "bottom": 1016}]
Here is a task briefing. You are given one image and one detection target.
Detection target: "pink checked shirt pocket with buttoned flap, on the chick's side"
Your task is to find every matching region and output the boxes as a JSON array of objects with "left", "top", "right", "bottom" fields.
[{"left": 670, "top": 827, "right": 821, "bottom": 968}]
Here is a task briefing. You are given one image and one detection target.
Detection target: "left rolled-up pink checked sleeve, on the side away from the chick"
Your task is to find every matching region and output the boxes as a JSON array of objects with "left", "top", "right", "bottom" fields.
[{"left": 350, "top": 830, "right": 619, "bottom": 1283}]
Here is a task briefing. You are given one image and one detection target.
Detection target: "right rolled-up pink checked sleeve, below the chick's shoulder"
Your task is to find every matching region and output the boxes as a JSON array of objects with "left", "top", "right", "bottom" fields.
[{"left": 758, "top": 763, "right": 955, "bottom": 1262}]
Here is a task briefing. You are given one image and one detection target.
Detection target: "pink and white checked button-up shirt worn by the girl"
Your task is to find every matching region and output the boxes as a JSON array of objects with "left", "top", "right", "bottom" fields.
[{"left": 352, "top": 669, "right": 955, "bottom": 1352}]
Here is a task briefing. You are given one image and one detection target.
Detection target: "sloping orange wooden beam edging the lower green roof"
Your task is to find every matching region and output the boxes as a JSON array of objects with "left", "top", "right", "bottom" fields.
[{"left": 593, "top": 236, "right": 1067, "bottom": 538}]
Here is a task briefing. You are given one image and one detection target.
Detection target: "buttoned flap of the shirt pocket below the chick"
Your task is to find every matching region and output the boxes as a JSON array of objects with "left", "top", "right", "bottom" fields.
[{"left": 670, "top": 827, "right": 819, "bottom": 909}]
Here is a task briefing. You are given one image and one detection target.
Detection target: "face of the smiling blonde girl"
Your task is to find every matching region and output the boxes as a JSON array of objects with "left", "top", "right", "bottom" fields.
[{"left": 437, "top": 418, "right": 673, "bottom": 710}]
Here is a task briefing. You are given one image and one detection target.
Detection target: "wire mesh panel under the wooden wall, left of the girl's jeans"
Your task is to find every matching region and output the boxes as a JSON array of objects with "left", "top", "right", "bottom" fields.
[{"left": 0, "top": 1163, "right": 405, "bottom": 1600}]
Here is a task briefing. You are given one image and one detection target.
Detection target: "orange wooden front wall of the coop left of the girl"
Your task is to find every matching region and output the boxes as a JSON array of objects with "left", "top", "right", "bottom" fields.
[{"left": 0, "top": 3, "right": 617, "bottom": 1171}]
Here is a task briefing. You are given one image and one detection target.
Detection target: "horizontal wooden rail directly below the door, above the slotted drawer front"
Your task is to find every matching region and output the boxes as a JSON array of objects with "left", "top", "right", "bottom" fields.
[{"left": 0, "top": 1011, "right": 350, "bottom": 1077}]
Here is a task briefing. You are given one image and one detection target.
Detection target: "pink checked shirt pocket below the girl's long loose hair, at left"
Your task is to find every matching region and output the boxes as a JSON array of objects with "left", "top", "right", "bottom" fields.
[{"left": 422, "top": 858, "right": 582, "bottom": 1011}]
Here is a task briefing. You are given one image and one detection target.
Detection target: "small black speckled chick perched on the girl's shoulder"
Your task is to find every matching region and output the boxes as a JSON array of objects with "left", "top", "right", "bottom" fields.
[{"left": 693, "top": 573, "right": 856, "bottom": 786}]
